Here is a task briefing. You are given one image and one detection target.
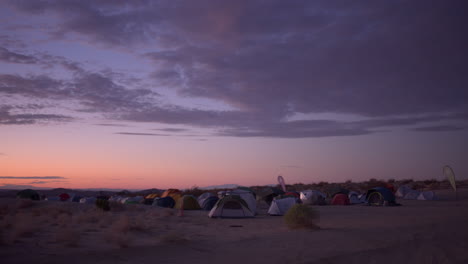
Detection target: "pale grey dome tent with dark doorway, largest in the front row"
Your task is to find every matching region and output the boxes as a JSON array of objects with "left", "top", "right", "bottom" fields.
[{"left": 208, "top": 195, "right": 255, "bottom": 218}]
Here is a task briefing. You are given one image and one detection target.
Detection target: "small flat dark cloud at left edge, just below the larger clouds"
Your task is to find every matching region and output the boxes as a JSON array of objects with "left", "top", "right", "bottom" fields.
[{"left": 0, "top": 106, "right": 73, "bottom": 125}]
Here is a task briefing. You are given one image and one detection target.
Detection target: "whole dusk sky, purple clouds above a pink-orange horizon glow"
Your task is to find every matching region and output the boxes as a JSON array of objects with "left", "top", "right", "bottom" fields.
[{"left": 0, "top": 0, "right": 468, "bottom": 189}]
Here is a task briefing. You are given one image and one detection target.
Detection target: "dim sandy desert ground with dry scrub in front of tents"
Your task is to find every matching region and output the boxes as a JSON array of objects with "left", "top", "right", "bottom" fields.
[{"left": 0, "top": 189, "right": 468, "bottom": 264}]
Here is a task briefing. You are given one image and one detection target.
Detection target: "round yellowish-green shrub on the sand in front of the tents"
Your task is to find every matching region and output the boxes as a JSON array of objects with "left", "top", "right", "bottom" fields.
[{"left": 284, "top": 204, "right": 320, "bottom": 229}]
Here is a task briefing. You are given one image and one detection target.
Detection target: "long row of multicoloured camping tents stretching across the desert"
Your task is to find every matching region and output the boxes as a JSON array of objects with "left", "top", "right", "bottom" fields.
[{"left": 14, "top": 186, "right": 435, "bottom": 218}]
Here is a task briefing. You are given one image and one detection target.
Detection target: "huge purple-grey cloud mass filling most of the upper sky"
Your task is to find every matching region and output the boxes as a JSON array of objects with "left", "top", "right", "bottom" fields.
[{"left": 5, "top": 0, "right": 468, "bottom": 138}]
